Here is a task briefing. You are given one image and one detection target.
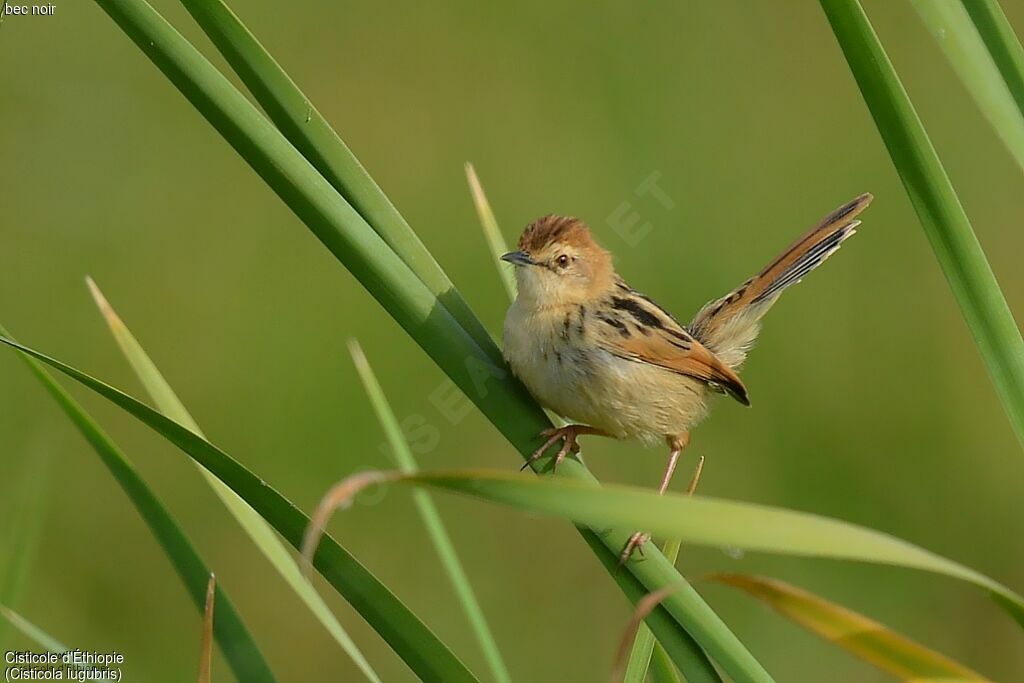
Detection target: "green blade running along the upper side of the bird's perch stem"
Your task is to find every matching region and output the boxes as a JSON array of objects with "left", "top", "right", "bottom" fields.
[{"left": 171, "top": 0, "right": 500, "bottom": 368}]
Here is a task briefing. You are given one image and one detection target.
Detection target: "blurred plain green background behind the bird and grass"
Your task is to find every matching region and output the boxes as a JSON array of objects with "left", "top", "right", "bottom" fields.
[{"left": 0, "top": 0, "right": 1024, "bottom": 682}]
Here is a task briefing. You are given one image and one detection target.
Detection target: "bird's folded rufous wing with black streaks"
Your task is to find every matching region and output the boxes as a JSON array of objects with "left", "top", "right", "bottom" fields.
[{"left": 596, "top": 283, "right": 750, "bottom": 405}]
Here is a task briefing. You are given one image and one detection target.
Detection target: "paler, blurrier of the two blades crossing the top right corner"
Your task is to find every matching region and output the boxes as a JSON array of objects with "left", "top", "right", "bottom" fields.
[{"left": 913, "top": 0, "right": 1024, "bottom": 169}]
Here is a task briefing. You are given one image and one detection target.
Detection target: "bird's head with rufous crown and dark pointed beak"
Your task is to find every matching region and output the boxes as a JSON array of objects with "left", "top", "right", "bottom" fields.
[{"left": 502, "top": 216, "right": 614, "bottom": 307}]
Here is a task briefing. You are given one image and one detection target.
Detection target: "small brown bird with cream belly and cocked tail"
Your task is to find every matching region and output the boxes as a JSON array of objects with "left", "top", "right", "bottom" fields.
[{"left": 502, "top": 194, "right": 872, "bottom": 561}]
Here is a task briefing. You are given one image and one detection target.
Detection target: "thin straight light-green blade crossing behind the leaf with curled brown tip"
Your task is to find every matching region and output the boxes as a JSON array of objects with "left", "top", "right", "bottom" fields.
[{"left": 348, "top": 340, "right": 512, "bottom": 683}]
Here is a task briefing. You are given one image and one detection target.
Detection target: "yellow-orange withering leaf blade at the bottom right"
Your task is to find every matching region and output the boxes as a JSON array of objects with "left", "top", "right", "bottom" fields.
[{"left": 711, "top": 573, "right": 988, "bottom": 683}]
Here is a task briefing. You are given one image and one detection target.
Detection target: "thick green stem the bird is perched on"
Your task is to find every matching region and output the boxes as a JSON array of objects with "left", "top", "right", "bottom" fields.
[{"left": 90, "top": 0, "right": 771, "bottom": 681}]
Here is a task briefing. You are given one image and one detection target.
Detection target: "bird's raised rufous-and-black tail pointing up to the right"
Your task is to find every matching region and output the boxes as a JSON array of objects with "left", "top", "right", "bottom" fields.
[{"left": 689, "top": 194, "right": 873, "bottom": 369}]
